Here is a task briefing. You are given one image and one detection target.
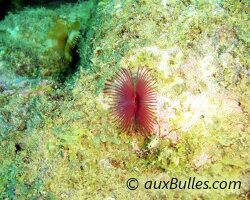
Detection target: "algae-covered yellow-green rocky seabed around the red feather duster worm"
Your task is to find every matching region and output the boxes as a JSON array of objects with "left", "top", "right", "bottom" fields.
[{"left": 0, "top": 0, "right": 250, "bottom": 199}]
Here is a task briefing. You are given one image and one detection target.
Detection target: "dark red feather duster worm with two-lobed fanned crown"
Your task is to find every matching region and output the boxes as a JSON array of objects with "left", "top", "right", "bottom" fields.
[{"left": 104, "top": 68, "right": 157, "bottom": 136}]
